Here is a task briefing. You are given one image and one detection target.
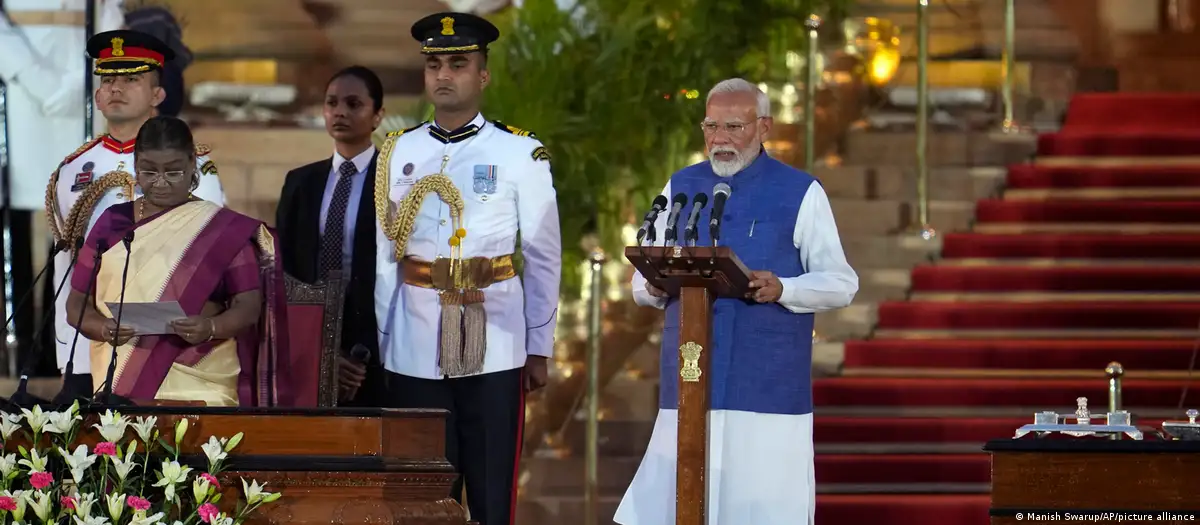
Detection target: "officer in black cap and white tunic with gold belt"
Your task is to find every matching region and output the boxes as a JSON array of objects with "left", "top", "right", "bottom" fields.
[{"left": 374, "top": 13, "right": 562, "bottom": 525}]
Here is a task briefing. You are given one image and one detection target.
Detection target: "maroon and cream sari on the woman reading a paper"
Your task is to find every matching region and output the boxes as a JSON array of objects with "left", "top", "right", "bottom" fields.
[{"left": 71, "top": 200, "right": 295, "bottom": 406}]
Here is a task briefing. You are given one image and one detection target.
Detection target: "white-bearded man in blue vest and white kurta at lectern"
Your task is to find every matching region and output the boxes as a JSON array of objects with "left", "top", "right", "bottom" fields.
[{"left": 613, "top": 79, "right": 858, "bottom": 525}]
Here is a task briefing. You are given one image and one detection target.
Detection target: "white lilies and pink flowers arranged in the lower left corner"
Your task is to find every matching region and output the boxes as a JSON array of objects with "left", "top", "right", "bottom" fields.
[{"left": 0, "top": 403, "right": 281, "bottom": 525}]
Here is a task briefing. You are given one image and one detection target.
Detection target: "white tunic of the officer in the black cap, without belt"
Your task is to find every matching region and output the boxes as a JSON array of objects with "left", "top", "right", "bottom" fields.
[{"left": 374, "top": 115, "right": 563, "bottom": 379}]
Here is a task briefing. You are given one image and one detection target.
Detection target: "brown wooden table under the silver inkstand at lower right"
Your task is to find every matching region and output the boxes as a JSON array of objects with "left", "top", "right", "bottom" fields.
[{"left": 984, "top": 438, "right": 1200, "bottom": 525}]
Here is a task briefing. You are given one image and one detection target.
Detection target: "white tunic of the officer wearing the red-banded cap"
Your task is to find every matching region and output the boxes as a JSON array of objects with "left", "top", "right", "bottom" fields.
[{"left": 50, "top": 135, "right": 226, "bottom": 374}]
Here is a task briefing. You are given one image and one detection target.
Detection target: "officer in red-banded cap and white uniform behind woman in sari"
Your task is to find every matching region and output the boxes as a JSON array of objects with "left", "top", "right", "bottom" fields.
[{"left": 46, "top": 30, "right": 224, "bottom": 400}]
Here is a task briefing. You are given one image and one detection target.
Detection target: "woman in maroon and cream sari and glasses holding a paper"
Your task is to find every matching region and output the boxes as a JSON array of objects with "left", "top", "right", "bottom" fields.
[{"left": 67, "top": 116, "right": 293, "bottom": 406}]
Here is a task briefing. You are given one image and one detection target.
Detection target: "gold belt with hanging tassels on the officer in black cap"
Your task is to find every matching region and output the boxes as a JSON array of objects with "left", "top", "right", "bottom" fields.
[{"left": 403, "top": 255, "right": 517, "bottom": 378}]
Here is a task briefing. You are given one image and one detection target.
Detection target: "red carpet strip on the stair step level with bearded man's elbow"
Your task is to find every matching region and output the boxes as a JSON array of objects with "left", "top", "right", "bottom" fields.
[{"left": 912, "top": 265, "right": 1200, "bottom": 292}]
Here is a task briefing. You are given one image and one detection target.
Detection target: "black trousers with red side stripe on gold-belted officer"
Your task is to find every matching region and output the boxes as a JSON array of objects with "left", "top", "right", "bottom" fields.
[{"left": 386, "top": 368, "right": 524, "bottom": 525}]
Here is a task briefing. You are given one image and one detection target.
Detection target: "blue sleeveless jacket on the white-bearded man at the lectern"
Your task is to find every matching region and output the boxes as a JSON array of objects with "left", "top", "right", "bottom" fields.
[{"left": 659, "top": 153, "right": 816, "bottom": 415}]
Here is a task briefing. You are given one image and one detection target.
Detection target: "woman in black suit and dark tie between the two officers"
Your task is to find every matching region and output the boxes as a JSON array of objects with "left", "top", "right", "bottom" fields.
[{"left": 275, "top": 66, "right": 384, "bottom": 406}]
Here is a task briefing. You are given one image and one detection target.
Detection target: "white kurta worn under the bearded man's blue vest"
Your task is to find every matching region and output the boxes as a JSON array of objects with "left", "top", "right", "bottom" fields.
[{"left": 613, "top": 175, "right": 858, "bottom": 525}]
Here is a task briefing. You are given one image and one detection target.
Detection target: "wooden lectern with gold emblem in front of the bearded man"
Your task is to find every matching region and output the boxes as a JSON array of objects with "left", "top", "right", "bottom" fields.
[{"left": 625, "top": 246, "right": 750, "bottom": 525}]
